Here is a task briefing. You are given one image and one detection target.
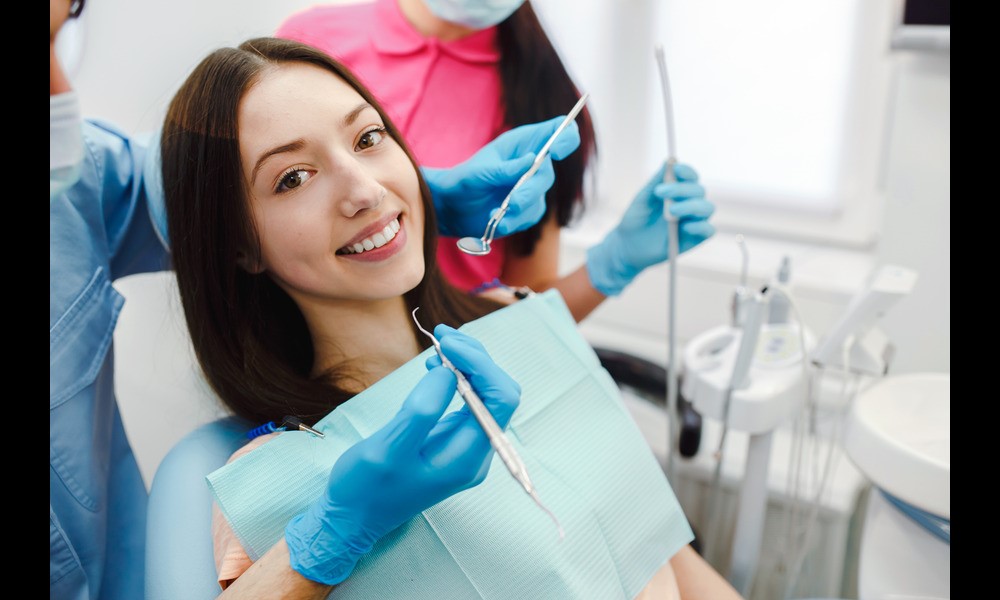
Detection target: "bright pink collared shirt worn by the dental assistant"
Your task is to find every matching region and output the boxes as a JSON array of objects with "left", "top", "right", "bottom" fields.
[{"left": 276, "top": 0, "right": 506, "bottom": 291}]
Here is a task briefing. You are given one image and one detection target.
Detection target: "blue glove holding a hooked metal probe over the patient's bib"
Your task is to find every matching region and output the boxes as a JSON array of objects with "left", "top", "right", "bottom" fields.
[{"left": 285, "top": 328, "right": 521, "bottom": 585}]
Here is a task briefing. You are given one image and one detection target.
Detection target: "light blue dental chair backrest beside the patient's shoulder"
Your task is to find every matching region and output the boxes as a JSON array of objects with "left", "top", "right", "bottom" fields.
[{"left": 146, "top": 417, "right": 251, "bottom": 600}]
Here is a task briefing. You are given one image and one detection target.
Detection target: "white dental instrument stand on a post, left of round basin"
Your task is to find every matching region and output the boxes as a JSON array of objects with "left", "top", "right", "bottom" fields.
[{"left": 681, "top": 288, "right": 814, "bottom": 597}]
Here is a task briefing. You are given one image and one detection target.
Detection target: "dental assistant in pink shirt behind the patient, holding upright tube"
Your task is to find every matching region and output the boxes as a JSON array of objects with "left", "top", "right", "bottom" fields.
[{"left": 276, "top": 0, "right": 715, "bottom": 321}]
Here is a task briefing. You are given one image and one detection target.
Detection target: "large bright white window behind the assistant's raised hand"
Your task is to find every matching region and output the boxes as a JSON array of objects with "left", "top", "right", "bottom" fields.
[{"left": 533, "top": 0, "right": 893, "bottom": 248}]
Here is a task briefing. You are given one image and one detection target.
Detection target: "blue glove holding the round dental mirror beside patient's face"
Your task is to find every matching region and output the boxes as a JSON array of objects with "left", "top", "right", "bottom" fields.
[{"left": 422, "top": 115, "right": 580, "bottom": 237}]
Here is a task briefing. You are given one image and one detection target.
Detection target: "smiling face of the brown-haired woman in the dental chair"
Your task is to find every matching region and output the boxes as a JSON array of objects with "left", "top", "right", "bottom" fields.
[{"left": 239, "top": 63, "right": 424, "bottom": 307}]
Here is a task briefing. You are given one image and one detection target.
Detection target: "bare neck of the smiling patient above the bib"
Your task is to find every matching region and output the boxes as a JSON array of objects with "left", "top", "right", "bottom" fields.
[{"left": 305, "top": 297, "right": 422, "bottom": 392}]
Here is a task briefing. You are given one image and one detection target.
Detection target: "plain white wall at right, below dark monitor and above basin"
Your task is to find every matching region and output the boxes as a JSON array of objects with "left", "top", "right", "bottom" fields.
[{"left": 877, "top": 52, "right": 951, "bottom": 372}]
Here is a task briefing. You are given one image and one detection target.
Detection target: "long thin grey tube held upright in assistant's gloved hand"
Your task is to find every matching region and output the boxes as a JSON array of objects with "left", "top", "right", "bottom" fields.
[{"left": 656, "top": 44, "right": 680, "bottom": 476}]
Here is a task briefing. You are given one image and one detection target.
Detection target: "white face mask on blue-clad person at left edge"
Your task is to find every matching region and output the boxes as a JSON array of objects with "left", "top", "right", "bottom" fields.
[{"left": 49, "top": 92, "right": 83, "bottom": 203}]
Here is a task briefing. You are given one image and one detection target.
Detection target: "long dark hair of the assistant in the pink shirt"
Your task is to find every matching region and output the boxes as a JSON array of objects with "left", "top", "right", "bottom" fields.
[{"left": 497, "top": 2, "right": 597, "bottom": 256}]
